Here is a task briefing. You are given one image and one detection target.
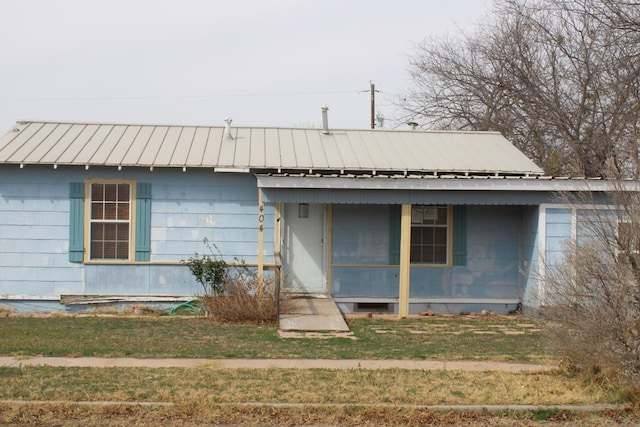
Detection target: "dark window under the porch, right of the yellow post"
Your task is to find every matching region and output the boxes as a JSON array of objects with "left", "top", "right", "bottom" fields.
[{"left": 411, "top": 205, "right": 451, "bottom": 265}]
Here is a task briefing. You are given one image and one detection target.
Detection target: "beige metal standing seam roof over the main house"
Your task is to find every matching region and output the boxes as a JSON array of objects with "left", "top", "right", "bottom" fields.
[{"left": 0, "top": 121, "right": 543, "bottom": 175}]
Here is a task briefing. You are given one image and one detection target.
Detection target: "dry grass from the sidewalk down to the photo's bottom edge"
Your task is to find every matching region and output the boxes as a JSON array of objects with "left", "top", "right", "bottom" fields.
[{"left": 0, "top": 367, "right": 639, "bottom": 426}]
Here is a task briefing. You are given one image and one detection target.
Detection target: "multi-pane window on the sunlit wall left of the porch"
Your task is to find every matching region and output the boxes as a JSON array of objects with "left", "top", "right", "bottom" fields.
[{"left": 89, "top": 182, "right": 132, "bottom": 261}]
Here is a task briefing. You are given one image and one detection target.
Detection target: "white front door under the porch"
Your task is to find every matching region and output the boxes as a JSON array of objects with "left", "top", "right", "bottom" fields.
[{"left": 282, "top": 203, "right": 327, "bottom": 293}]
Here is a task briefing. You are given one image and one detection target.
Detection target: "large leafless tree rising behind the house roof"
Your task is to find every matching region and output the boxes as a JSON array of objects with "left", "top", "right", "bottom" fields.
[{"left": 403, "top": 0, "right": 640, "bottom": 177}]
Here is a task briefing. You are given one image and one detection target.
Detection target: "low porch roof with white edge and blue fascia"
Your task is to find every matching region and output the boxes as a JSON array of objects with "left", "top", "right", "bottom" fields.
[{"left": 257, "top": 175, "right": 640, "bottom": 205}]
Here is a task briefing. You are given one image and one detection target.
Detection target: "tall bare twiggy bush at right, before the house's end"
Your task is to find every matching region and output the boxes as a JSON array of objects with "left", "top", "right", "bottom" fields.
[{"left": 541, "top": 191, "right": 640, "bottom": 391}]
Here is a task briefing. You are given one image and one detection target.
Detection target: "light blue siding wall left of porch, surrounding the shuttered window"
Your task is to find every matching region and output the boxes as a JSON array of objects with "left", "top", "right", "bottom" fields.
[{"left": 0, "top": 166, "right": 274, "bottom": 297}]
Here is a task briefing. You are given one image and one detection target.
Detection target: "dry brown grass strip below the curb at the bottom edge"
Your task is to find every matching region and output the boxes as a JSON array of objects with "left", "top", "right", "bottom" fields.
[{"left": 0, "top": 403, "right": 638, "bottom": 427}]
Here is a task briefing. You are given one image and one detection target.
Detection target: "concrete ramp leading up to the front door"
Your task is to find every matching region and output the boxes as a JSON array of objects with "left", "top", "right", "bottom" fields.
[{"left": 278, "top": 294, "right": 351, "bottom": 334}]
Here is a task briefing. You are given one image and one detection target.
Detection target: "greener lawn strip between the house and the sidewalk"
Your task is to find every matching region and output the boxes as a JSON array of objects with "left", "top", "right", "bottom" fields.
[{"left": 0, "top": 316, "right": 549, "bottom": 361}]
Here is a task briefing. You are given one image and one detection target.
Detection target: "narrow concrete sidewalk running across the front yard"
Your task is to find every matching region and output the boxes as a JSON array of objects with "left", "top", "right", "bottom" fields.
[{"left": 0, "top": 357, "right": 556, "bottom": 372}]
